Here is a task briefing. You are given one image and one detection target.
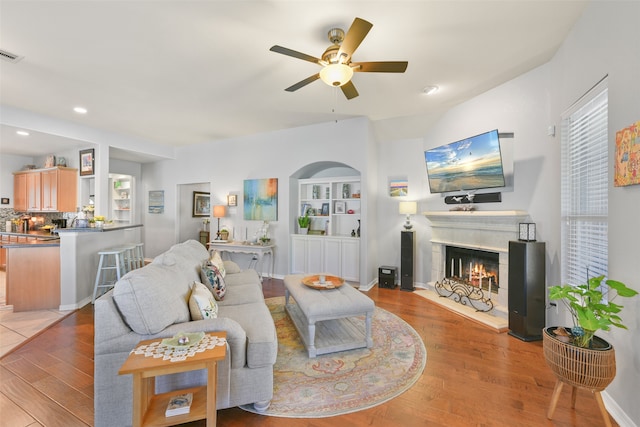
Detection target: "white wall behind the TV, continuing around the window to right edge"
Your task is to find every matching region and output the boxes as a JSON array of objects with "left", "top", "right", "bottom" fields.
[{"left": 378, "top": 2, "right": 640, "bottom": 426}]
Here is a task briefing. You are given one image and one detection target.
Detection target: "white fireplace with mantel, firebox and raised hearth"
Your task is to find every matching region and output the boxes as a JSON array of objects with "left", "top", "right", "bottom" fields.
[{"left": 424, "top": 211, "right": 530, "bottom": 329}]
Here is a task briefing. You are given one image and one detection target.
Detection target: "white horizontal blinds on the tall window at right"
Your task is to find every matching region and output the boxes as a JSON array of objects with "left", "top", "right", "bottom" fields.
[{"left": 561, "top": 78, "right": 609, "bottom": 285}]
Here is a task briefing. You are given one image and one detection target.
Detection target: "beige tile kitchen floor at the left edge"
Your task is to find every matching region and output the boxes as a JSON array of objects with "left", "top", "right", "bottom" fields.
[{"left": 0, "top": 270, "right": 73, "bottom": 357}]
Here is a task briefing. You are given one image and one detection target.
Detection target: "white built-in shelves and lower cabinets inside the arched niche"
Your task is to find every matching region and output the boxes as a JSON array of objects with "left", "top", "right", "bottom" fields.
[{"left": 290, "top": 177, "right": 361, "bottom": 282}]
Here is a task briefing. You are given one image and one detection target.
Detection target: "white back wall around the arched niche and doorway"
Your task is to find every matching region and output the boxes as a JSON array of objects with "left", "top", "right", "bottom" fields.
[{"left": 142, "top": 118, "right": 377, "bottom": 282}]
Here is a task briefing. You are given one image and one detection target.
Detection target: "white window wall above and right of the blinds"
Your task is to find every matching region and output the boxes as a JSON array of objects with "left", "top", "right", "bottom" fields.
[{"left": 551, "top": 1, "right": 640, "bottom": 426}]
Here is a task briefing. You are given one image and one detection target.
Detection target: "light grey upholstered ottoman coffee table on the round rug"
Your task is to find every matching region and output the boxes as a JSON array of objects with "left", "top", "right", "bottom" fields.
[{"left": 284, "top": 274, "right": 375, "bottom": 358}]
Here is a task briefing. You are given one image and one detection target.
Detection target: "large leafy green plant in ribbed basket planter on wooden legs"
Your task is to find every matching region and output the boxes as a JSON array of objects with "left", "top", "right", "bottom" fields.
[{"left": 542, "top": 276, "right": 638, "bottom": 426}]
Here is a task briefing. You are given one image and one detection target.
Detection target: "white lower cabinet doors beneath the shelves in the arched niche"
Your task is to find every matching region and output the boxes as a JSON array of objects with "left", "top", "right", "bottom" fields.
[{"left": 290, "top": 234, "right": 360, "bottom": 282}]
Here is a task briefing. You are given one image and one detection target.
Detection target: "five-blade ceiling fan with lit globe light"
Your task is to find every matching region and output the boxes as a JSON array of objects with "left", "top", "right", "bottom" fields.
[{"left": 269, "top": 18, "right": 408, "bottom": 99}]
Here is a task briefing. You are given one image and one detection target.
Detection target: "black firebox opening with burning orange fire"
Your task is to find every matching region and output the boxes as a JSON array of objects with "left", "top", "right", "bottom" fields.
[{"left": 444, "top": 246, "right": 500, "bottom": 293}]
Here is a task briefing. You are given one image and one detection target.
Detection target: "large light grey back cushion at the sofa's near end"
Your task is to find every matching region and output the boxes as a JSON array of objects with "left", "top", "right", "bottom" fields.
[{"left": 113, "top": 264, "right": 191, "bottom": 335}]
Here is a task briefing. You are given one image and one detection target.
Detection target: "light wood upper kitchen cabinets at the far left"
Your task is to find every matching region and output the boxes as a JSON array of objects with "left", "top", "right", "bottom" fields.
[{"left": 13, "top": 166, "right": 78, "bottom": 212}]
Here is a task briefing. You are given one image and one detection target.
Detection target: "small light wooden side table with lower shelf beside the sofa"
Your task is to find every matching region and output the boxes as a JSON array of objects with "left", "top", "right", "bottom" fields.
[{"left": 118, "top": 332, "right": 227, "bottom": 427}]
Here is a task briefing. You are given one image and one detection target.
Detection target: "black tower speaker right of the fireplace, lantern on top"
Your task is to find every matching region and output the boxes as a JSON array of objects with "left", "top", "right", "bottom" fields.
[{"left": 509, "top": 241, "right": 546, "bottom": 341}]
